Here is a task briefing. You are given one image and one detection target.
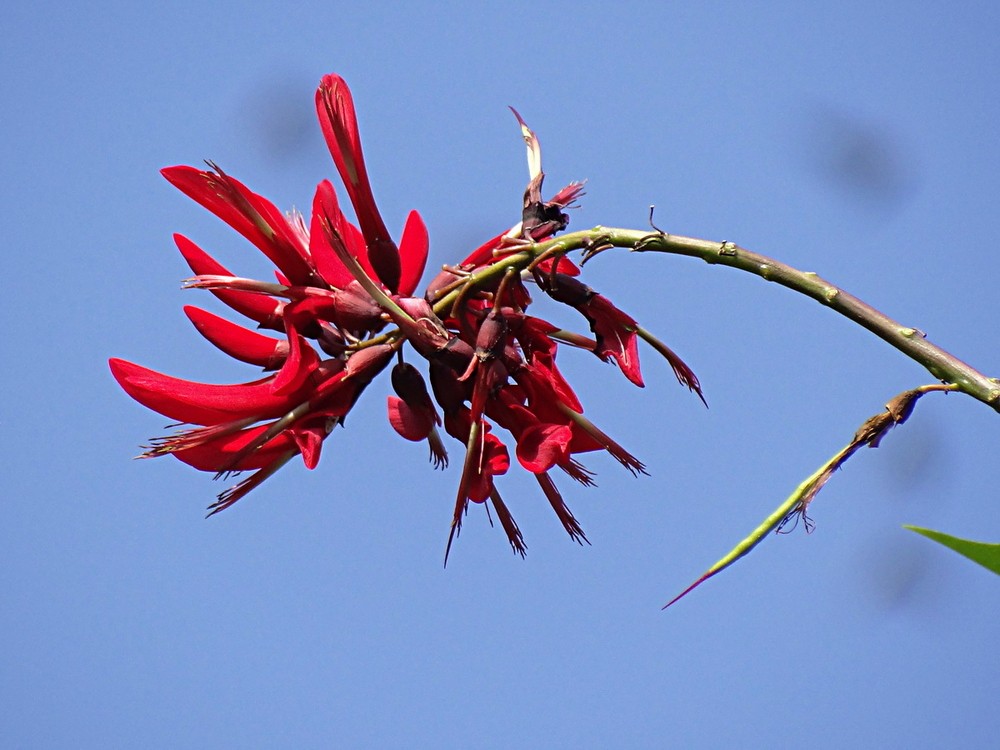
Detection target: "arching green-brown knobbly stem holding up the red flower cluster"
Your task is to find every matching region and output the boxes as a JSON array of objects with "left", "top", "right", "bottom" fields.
[{"left": 434, "top": 226, "right": 1000, "bottom": 412}]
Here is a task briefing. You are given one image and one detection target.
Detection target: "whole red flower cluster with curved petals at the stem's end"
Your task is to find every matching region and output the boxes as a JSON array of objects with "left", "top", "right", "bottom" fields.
[{"left": 110, "top": 75, "right": 701, "bottom": 559}]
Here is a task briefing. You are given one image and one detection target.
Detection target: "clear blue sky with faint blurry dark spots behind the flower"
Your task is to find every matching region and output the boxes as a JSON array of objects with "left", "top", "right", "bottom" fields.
[{"left": 0, "top": 2, "right": 1000, "bottom": 748}]
